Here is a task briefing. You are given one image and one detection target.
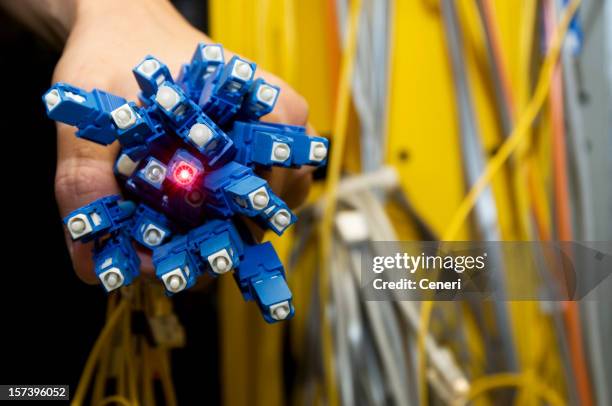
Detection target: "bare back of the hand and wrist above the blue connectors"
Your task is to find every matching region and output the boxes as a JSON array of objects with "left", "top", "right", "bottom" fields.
[{"left": 54, "top": 0, "right": 207, "bottom": 88}]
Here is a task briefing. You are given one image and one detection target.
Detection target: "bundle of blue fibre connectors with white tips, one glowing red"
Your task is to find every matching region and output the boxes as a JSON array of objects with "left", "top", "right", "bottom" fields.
[{"left": 43, "top": 43, "right": 329, "bottom": 323}]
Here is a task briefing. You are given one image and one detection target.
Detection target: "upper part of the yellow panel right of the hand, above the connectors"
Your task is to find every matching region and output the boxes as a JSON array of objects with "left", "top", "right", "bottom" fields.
[{"left": 210, "top": 0, "right": 334, "bottom": 134}]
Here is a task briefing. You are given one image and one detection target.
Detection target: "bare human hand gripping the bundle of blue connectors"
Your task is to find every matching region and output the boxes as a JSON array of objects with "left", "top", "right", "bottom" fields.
[{"left": 53, "top": 0, "right": 312, "bottom": 283}]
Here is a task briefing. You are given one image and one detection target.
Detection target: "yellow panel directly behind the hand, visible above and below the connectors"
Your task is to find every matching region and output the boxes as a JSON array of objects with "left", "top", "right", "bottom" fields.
[{"left": 209, "top": 0, "right": 335, "bottom": 406}]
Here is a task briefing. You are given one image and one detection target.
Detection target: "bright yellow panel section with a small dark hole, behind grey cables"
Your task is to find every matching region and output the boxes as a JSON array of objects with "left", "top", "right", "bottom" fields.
[{"left": 387, "top": 1, "right": 468, "bottom": 238}]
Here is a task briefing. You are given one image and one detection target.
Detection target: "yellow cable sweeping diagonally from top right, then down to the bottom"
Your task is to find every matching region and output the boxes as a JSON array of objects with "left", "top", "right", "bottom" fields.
[{"left": 417, "top": 0, "right": 581, "bottom": 406}]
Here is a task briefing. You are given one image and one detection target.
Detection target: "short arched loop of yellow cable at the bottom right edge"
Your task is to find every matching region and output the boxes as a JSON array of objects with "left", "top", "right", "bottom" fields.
[{"left": 462, "top": 373, "right": 565, "bottom": 406}]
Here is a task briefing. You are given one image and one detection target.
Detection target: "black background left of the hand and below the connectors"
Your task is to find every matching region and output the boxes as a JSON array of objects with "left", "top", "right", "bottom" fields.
[{"left": 0, "top": 0, "right": 219, "bottom": 404}]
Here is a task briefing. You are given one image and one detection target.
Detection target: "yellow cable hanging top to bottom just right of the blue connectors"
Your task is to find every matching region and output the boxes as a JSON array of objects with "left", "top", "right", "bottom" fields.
[{"left": 319, "top": 0, "right": 361, "bottom": 406}]
